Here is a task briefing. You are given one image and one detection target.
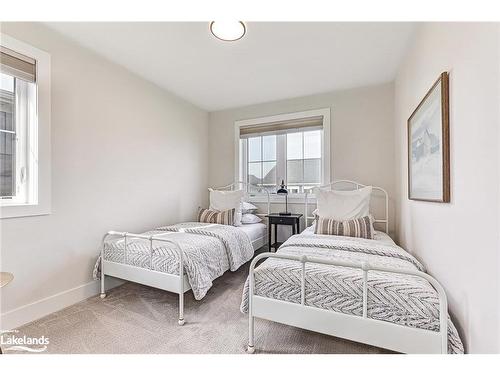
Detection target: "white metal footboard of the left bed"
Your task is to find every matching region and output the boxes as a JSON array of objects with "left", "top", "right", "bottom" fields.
[{"left": 100, "top": 230, "right": 190, "bottom": 326}]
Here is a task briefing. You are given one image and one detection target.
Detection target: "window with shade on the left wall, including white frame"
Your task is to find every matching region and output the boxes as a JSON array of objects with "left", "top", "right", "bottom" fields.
[{"left": 0, "top": 35, "right": 50, "bottom": 218}]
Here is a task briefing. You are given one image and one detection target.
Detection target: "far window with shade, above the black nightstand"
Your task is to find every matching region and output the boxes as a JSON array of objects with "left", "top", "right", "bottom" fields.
[{"left": 236, "top": 110, "right": 330, "bottom": 195}]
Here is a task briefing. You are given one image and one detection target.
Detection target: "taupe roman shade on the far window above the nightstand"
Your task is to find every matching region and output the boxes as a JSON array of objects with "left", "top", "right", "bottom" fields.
[{"left": 240, "top": 116, "right": 323, "bottom": 138}]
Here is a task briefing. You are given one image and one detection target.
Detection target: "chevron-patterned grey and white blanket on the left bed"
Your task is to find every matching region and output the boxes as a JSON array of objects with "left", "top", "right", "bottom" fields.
[{"left": 94, "top": 223, "right": 254, "bottom": 300}]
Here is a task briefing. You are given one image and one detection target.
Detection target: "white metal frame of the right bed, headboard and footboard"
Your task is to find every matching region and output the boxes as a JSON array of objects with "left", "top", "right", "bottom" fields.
[{"left": 247, "top": 180, "right": 448, "bottom": 353}]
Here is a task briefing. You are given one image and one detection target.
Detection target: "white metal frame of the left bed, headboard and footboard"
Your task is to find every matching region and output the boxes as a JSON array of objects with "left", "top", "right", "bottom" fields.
[{"left": 100, "top": 182, "right": 270, "bottom": 326}]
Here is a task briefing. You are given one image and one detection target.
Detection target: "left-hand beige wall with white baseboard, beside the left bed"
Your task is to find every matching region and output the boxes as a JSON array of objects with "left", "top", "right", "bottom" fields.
[{"left": 0, "top": 23, "right": 208, "bottom": 329}]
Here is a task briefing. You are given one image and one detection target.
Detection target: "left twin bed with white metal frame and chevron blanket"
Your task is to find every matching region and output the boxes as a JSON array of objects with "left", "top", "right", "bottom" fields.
[{"left": 94, "top": 183, "right": 270, "bottom": 325}]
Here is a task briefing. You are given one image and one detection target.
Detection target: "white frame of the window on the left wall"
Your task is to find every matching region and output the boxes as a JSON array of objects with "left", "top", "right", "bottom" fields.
[{"left": 0, "top": 33, "right": 51, "bottom": 219}]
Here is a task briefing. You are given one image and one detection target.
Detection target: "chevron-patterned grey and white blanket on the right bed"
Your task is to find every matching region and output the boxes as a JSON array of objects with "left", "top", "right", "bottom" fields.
[{"left": 241, "top": 234, "right": 464, "bottom": 353}]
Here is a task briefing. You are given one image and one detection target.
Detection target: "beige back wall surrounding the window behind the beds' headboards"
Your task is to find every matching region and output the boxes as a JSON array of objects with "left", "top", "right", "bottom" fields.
[{"left": 208, "top": 83, "right": 394, "bottom": 231}]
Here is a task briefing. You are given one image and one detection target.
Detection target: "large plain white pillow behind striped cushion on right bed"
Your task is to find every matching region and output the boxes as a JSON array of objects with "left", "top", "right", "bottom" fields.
[{"left": 316, "top": 186, "right": 372, "bottom": 221}]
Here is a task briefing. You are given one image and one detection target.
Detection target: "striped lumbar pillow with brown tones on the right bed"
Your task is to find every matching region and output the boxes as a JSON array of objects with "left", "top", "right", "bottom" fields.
[{"left": 314, "top": 215, "right": 374, "bottom": 240}]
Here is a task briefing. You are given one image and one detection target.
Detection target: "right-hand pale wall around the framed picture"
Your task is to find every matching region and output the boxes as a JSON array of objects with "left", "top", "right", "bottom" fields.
[{"left": 395, "top": 23, "right": 500, "bottom": 353}]
